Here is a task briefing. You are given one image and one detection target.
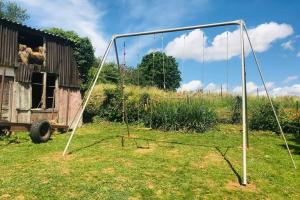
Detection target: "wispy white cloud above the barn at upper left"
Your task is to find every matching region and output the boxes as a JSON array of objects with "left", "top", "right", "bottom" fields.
[{"left": 16, "top": 0, "right": 107, "bottom": 56}]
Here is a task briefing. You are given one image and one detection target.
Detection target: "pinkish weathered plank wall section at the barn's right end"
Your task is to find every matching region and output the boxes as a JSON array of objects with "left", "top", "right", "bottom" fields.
[{"left": 58, "top": 88, "right": 82, "bottom": 128}]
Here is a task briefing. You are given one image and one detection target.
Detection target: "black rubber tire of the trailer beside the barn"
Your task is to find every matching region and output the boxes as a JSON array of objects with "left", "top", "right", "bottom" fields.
[{"left": 29, "top": 120, "right": 52, "bottom": 143}]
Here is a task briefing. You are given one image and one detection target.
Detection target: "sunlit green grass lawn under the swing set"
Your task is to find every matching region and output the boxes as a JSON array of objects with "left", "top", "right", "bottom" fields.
[{"left": 0, "top": 122, "right": 300, "bottom": 199}]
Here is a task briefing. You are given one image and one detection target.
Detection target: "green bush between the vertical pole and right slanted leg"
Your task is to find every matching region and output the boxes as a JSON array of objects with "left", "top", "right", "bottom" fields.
[{"left": 249, "top": 101, "right": 279, "bottom": 132}]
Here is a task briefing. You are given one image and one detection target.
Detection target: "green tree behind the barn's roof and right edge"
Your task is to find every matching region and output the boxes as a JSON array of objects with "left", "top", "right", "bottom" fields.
[{"left": 45, "top": 28, "right": 95, "bottom": 88}]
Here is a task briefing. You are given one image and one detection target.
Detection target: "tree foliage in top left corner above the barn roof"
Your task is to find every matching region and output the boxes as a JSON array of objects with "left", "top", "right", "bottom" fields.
[{"left": 0, "top": 0, "right": 29, "bottom": 23}]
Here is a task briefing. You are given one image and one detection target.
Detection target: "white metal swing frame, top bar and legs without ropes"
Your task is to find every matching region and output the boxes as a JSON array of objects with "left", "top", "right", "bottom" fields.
[{"left": 63, "top": 20, "right": 296, "bottom": 186}]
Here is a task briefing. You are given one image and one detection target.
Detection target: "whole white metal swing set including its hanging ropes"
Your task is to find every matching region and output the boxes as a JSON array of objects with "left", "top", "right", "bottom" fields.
[{"left": 63, "top": 20, "right": 296, "bottom": 185}]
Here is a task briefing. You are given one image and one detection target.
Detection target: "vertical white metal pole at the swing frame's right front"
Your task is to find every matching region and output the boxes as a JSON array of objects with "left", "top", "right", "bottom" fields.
[{"left": 240, "top": 20, "right": 248, "bottom": 185}]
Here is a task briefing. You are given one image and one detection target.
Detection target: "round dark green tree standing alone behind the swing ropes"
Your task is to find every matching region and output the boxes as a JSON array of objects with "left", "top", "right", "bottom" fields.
[{"left": 137, "top": 52, "right": 181, "bottom": 90}]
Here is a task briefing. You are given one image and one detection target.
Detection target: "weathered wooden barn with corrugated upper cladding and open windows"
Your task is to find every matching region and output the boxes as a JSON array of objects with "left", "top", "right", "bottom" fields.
[{"left": 0, "top": 18, "right": 82, "bottom": 141}]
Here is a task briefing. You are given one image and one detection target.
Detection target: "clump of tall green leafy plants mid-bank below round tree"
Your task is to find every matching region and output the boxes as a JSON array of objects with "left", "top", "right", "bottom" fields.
[{"left": 144, "top": 100, "right": 217, "bottom": 132}]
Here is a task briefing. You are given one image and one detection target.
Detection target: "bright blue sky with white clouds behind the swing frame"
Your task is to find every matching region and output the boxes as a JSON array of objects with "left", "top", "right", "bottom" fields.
[{"left": 16, "top": 0, "right": 300, "bottom": 95}]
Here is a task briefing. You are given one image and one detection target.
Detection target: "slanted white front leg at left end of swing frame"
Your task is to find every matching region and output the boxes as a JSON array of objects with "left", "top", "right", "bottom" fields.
[{"left": 63, "top": 37, "right": 114, "bottom": 156}]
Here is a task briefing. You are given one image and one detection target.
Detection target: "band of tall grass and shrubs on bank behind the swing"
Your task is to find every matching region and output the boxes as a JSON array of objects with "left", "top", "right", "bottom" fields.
[{"left": 85, "top": 84, "right": 300, "bottom": 133}]
